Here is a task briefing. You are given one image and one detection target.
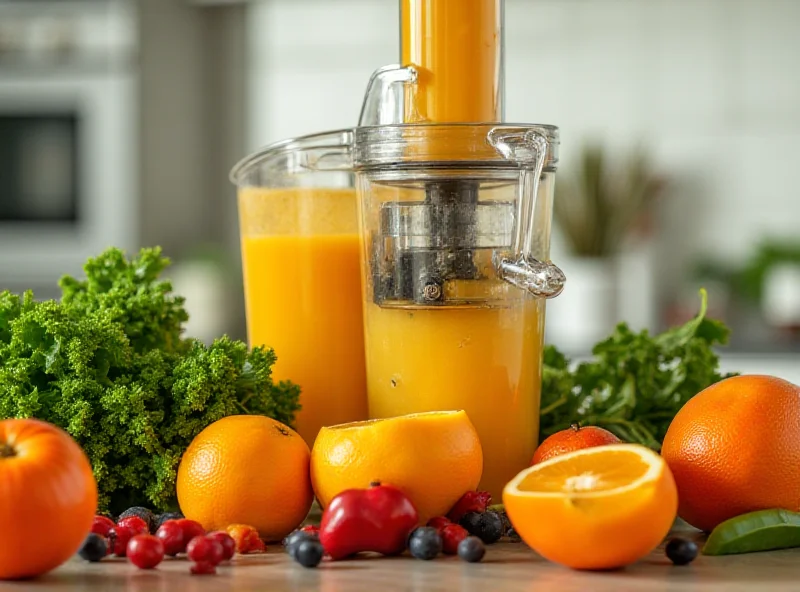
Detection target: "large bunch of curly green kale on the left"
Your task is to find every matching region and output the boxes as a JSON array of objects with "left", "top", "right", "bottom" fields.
[{"left": 0, "top": 249, "right": 299, "bottom": 512}]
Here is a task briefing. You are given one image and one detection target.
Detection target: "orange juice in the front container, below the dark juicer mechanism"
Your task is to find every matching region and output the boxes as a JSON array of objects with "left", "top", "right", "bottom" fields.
[{"left": 365, "top": 298, "right": 544, "bottom": 501}]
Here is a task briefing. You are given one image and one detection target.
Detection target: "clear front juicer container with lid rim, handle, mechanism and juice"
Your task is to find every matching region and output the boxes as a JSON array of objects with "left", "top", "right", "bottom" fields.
[{"left": 353, "top": 123, "right": 565, "bottom": 499}]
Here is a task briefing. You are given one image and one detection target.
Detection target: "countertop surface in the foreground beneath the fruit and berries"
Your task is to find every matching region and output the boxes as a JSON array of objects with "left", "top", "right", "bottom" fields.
[{"left": 6, "top": 533, "right": 800, "bottom": 592}]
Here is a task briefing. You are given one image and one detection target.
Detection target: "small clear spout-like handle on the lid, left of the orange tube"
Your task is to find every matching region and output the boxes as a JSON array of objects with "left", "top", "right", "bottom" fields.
[{"left": 358, "top": 65, "right": 417, "bottom": 127}]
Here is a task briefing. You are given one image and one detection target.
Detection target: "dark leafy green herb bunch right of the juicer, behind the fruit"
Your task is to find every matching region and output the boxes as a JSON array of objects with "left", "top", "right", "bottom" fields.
[{"left": 540, "top": 290, "right": 729, "bottom": 450}]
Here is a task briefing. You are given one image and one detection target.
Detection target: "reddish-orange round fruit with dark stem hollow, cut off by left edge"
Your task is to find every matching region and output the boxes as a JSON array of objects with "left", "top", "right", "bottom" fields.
[{"left": 0, "top": 419, "right": 97, "bottom": 579}]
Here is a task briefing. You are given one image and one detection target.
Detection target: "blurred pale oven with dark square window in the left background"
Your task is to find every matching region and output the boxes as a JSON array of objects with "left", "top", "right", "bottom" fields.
[{"left": 0, "top": 1, "right": 138, "bottom": 289}]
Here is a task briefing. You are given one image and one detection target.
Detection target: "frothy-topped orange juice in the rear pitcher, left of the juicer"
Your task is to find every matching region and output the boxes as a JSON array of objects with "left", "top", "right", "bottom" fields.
[{"left": 239, "top": 188, "right": 367, "bottom": 446}]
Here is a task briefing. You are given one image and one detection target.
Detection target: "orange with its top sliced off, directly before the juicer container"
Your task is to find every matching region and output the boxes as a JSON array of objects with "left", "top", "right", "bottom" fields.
[{"left": 311, "top": 411, "right": 483, "bottom": 522}]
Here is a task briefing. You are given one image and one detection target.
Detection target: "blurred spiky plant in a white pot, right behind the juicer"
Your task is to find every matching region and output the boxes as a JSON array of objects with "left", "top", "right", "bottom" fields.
[{"left": 547, "top": 144, "right": 665, "bottom": 353}]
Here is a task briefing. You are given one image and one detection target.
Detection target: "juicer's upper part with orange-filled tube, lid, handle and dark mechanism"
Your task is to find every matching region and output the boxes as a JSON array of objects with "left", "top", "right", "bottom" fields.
[{"left": 360, "top": 0, "right": 564, "bottom": 306}]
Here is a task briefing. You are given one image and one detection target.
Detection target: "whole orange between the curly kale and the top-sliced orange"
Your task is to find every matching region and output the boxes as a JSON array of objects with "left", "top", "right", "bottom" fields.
[{"left": 177, "top": 415, "right": 314, "bottom": 541}]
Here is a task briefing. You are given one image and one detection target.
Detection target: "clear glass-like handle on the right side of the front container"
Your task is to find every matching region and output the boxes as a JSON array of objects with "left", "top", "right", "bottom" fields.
[{"left": 487, "top": 128, "right": 567, "bottom": 298}]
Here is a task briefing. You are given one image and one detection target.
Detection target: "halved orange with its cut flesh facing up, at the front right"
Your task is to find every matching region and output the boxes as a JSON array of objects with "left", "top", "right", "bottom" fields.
[{"left": 503, "top": 444, "right": 678, "bottom": 569}]
